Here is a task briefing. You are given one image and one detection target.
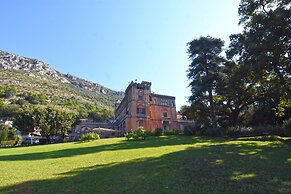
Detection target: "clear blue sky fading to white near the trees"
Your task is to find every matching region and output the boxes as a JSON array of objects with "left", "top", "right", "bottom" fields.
[{"left": 0, "top": 0, "right": 242, "bottom": 110}]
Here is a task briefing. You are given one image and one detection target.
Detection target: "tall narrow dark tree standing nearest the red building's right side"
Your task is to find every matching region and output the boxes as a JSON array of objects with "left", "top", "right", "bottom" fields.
[{"left": 187, "top": 36, "right": 224, "bottom": 128}]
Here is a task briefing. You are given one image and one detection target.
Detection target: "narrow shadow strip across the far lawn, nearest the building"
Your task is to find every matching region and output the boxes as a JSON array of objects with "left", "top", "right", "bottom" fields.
[{"left": 0, "top": 135, "right": 223, "bottom": 161}]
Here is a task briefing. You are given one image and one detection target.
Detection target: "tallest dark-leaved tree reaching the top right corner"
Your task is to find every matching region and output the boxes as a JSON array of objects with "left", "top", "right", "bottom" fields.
[{"left": 228, "top": 0, "right": 291, "bottom": 116}]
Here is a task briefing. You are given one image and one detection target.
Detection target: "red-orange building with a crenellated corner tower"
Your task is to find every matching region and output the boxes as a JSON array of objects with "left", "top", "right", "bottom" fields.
[{"left": 115, "top": 81, "right": 180, "bottom": 133}]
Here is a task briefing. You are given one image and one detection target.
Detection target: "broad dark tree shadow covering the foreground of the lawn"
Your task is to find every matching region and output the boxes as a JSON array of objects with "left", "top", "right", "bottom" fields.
[{"left": 0, "top": 140, "right": 291, "bottom": 194}]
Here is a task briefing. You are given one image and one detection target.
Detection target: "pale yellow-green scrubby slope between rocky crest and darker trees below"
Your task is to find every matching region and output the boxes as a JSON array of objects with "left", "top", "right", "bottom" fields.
[{"left": 0, "top": 70, "right": 120, "bottom": 109}]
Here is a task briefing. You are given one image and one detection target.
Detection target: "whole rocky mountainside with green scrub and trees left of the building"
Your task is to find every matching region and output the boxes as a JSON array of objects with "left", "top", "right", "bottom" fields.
[{"left": 0, "top": 50, "right": 124, "bottom": 120}]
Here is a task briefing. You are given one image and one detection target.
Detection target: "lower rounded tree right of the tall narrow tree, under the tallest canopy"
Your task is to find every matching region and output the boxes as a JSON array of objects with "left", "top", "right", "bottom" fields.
[{"left": 215, "top": 61, "right": 267, "bottom": 126}]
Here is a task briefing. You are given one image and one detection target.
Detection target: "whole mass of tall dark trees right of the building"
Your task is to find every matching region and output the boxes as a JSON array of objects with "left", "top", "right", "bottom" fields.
[{"left": 186, "top": 0, "right": 291, "bottom": 129}]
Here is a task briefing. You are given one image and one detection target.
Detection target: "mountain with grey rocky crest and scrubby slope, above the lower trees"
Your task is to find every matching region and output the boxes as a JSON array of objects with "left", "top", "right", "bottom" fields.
[{"left": 0, "top": 50, "right": 124, "bottom": 110}]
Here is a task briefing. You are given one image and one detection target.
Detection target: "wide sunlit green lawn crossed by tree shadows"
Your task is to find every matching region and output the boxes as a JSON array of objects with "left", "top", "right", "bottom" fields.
[{"left": 0, "top": 136, "right": 291, "bottom": 194}]
